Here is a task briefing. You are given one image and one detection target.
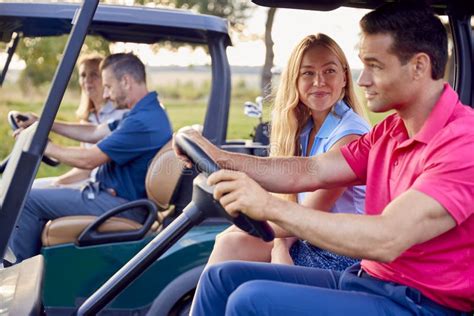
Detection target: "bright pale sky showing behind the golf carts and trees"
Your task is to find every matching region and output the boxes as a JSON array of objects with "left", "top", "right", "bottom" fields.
[{"left": 0, "top": 7, "right": 367, "bottom": 68}]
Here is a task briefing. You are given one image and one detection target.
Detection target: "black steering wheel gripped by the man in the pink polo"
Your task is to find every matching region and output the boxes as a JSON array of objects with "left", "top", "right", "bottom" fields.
[{"left": 175, "top": 133, "right": 275, "bottom": 241}]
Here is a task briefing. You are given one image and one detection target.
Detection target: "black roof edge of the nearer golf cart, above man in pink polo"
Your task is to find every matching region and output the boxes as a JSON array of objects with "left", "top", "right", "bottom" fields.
[{"left": 252, "top": 0, "right": 474, "bottom": 15}]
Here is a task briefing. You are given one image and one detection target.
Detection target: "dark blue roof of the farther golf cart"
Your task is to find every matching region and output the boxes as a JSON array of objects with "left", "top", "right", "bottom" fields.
[{"left": 0, "top": 2, "right": 230, "bottom": 44}]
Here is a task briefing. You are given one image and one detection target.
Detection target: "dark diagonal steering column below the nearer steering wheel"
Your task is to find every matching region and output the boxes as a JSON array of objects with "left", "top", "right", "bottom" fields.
[{"left": 76, "top": 202, "right": 202, "bottom": 315}]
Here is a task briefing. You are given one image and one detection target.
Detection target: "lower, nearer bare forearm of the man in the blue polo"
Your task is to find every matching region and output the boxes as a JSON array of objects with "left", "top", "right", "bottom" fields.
[{"left": 44, "top": 142, "right": 110, "bottom": 170}]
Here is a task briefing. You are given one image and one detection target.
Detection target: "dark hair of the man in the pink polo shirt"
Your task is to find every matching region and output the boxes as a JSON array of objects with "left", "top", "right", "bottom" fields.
[{"left": 360, "top": 1, "right": 448, "bottom": 80}]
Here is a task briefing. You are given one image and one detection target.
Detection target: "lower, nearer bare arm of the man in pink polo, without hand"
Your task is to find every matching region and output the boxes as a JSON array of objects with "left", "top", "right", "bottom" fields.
[{"left": 269, "top": 190, "right": 456, "bottom": 262}]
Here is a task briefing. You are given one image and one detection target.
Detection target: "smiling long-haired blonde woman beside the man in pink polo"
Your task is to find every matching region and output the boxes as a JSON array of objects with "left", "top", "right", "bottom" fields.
[{"left": 208, "top": 34, "right": 370, "bottom": 270}]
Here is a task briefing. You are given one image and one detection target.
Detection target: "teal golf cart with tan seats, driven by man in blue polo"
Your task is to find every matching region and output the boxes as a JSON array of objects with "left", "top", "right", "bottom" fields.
[{"left": 0, "top": 0, "right": 270, "bottom": 315}]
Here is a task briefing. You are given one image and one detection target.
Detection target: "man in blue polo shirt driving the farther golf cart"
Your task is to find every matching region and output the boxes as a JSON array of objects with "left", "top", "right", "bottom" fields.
[{"left": 9, "top": 54, "right": 172, "bottom": 262}]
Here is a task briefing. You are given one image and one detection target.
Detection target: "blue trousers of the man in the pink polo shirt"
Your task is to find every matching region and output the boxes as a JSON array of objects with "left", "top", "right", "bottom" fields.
[{"left": 191, "top": 261, "right": 460, "bottom": 316}]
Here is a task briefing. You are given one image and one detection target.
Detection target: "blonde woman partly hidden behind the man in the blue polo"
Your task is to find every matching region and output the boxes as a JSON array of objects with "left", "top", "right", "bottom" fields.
[{"left": 33, "top": 55, "right": 128, "bottom": 188}]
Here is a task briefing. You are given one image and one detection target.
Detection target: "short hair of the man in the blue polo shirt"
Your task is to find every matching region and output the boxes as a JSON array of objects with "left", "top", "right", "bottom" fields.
[{"left": 100, "top": 53, "right": 146, "bottom": 83}]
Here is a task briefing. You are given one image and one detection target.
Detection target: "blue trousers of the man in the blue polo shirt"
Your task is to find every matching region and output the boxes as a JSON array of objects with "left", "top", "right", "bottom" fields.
[{"left": 9, "top": 185, "right": 139, "bottom": 262}]
